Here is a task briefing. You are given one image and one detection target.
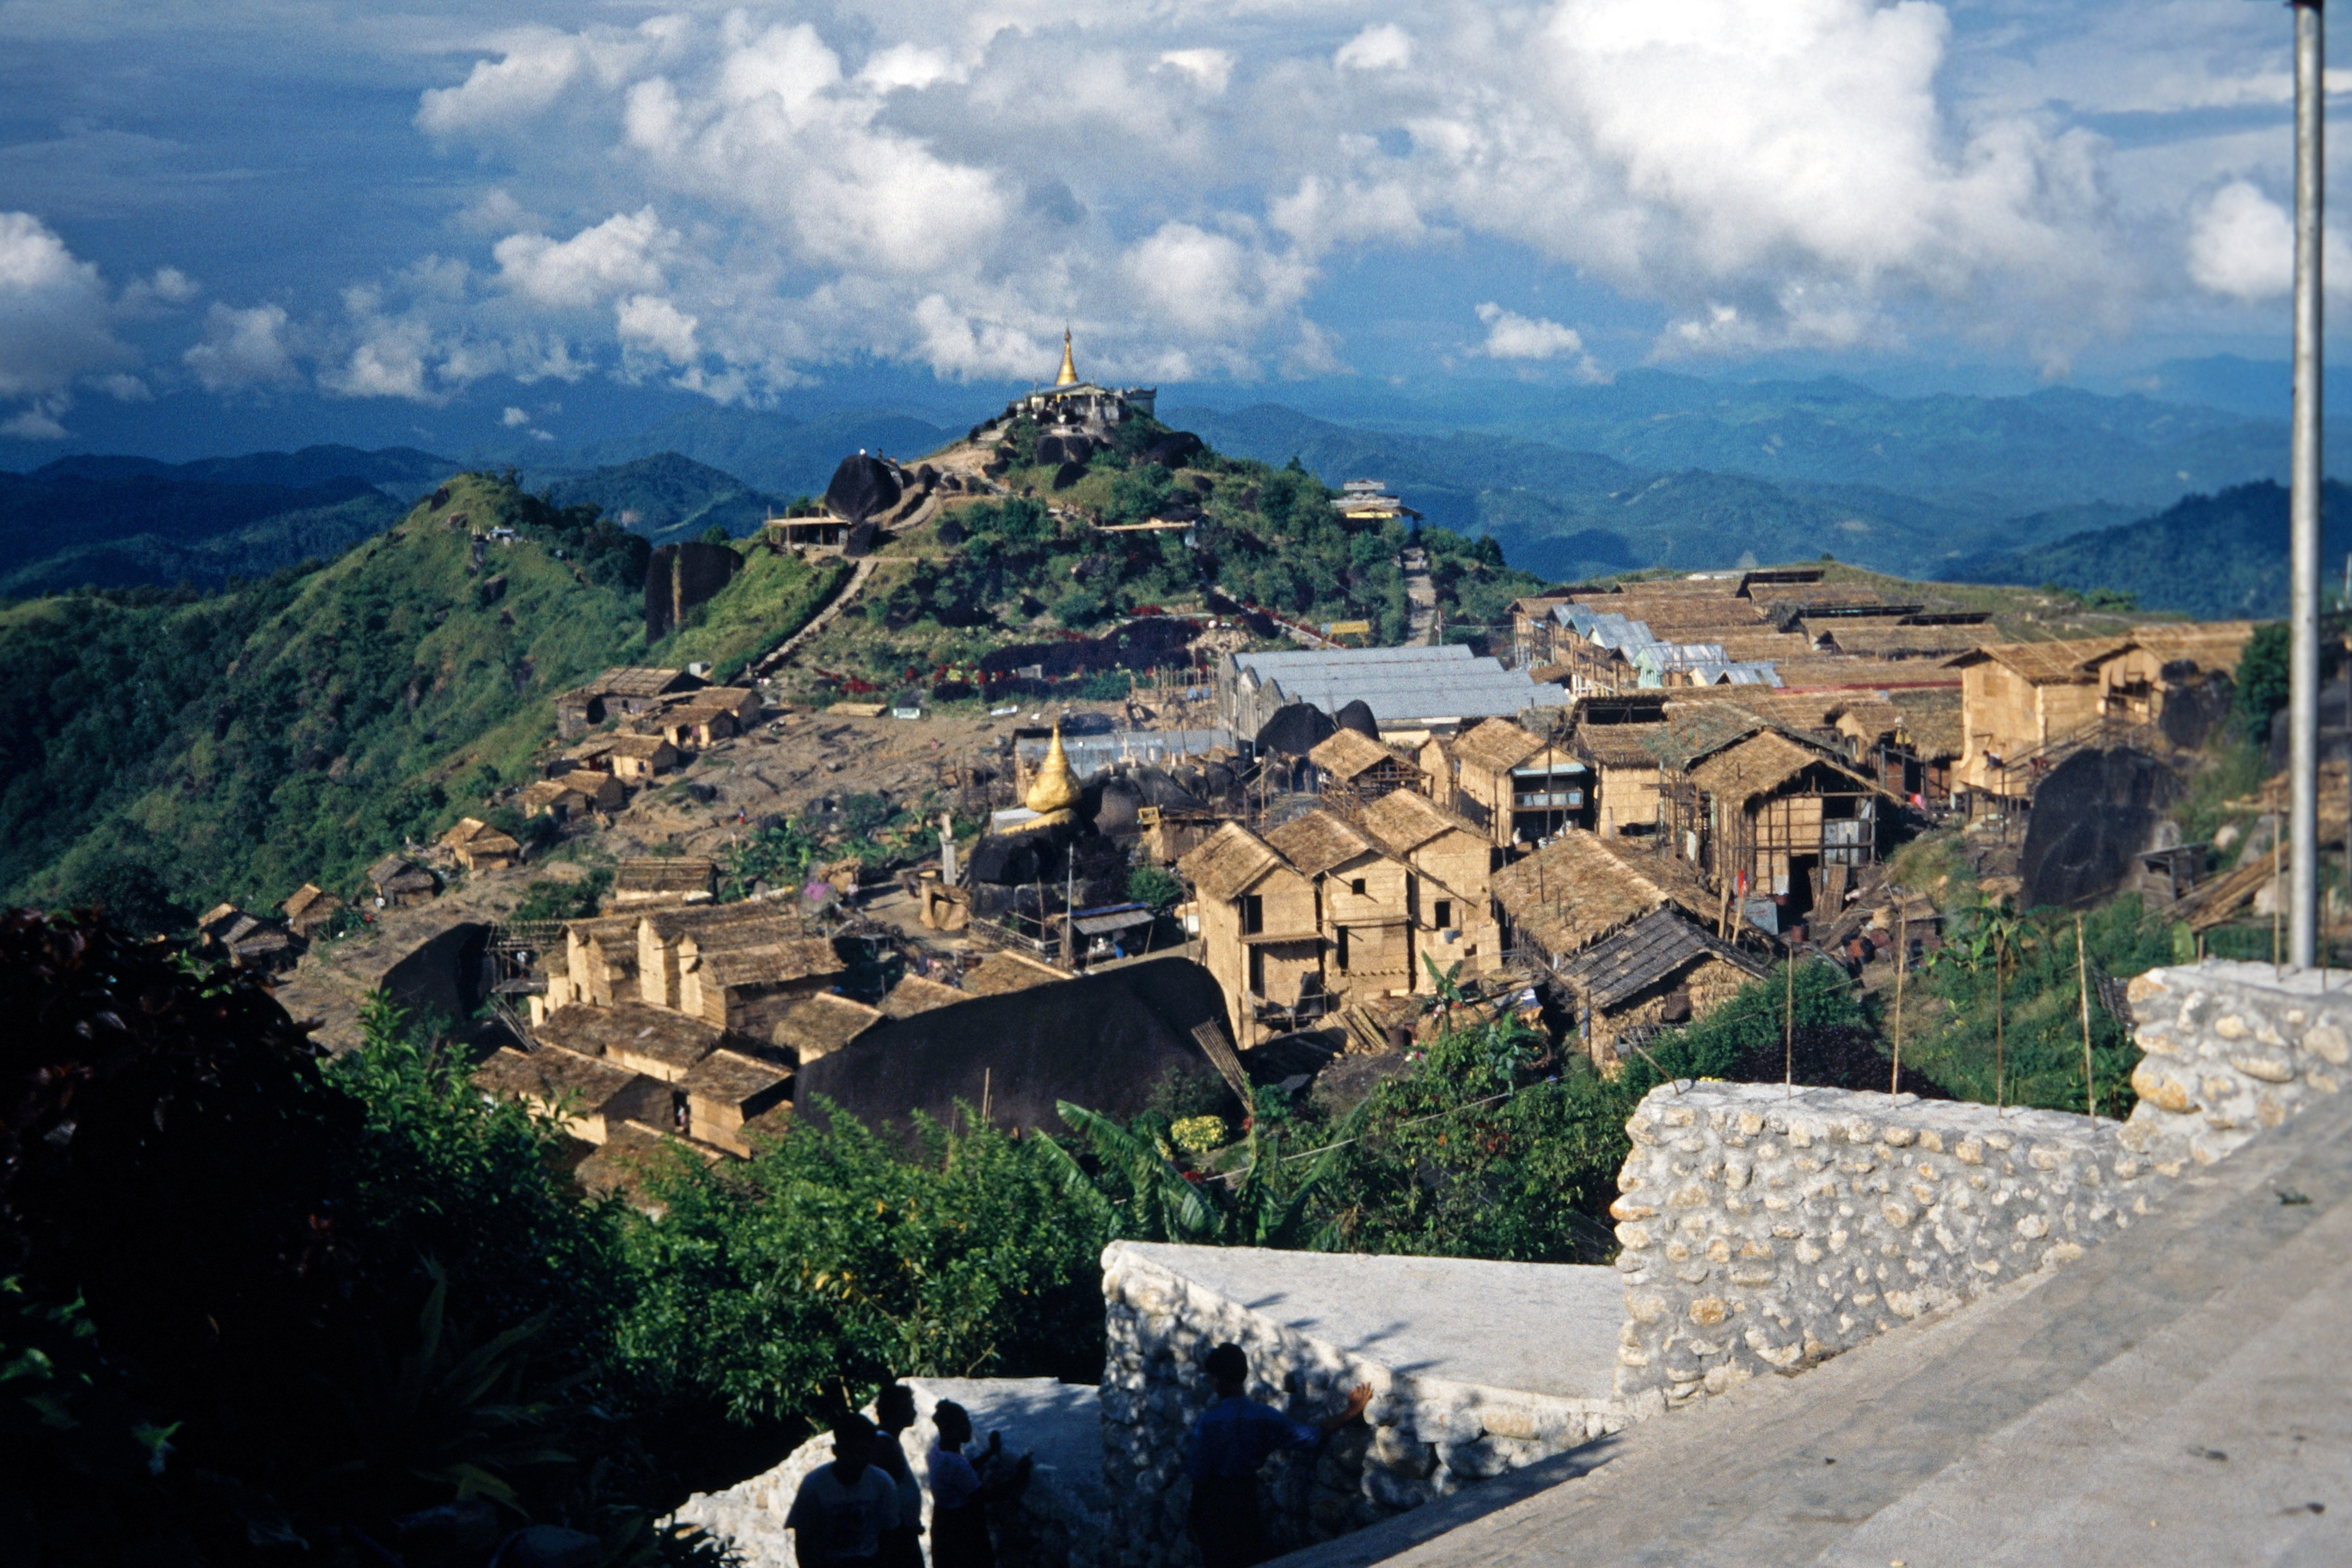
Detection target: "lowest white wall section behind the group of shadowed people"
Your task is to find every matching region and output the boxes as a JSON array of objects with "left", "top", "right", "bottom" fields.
[{"left": 675, "top": 1377, "right": 1115, "bottom": 1568}]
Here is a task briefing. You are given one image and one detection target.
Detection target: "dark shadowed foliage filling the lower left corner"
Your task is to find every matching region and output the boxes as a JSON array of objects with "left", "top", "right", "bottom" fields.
[{"left": 0, "top": 915, "right": 705, "bottom": 1564}]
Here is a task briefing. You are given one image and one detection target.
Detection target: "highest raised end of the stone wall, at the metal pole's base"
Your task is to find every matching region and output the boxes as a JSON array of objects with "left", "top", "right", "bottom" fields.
[{"left": 2124, "top": 959, "right": 2352, "bottom": 1175}]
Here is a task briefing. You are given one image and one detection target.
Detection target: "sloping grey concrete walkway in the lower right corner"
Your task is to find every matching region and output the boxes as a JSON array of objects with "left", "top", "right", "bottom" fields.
[{"left": 1279, "top": 1081, "right": 2352, "bottom": 1568}]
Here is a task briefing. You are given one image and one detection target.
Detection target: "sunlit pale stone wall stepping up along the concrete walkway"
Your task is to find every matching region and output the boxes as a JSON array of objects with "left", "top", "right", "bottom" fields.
[{"left": 1611, "top": 961, "right": 2352, "bottom": 1418}]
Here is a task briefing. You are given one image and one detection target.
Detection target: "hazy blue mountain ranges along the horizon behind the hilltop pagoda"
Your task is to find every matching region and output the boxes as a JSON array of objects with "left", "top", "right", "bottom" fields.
[{"left": 0, "top": 359, "right": 2348, "bottom": 607}]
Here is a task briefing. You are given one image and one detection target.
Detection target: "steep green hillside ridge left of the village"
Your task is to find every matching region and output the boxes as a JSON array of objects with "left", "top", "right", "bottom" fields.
[{"left": 0, "top": 475, "right": 837, "bottom": 908}]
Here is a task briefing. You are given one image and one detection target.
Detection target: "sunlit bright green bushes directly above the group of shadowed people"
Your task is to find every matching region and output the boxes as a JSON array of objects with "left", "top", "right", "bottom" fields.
[{"left": 619, "top": 1114, "right": 1106, "bottom": 1420}]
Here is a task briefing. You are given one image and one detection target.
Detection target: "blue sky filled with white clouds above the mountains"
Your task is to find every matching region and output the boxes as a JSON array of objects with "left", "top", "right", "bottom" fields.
[{"left": 0, "top": 0, "right": 2352, "bottom": 449}]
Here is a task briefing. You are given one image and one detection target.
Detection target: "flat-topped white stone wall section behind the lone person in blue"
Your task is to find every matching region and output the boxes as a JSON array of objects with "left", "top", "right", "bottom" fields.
[{"left": 1103, "top": 1241, "right": 1626, "bottom": 1568}]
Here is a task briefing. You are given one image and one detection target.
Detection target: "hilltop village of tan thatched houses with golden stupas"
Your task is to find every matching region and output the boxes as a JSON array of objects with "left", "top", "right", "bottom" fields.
[{"left": 170, "top": 343, "right": 2268, "bottom": 1190}]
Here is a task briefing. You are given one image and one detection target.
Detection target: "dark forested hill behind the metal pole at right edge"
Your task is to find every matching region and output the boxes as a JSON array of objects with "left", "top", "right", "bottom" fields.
[{"left": 1947, "top": 480, "right": 2352, "bottom": 621}]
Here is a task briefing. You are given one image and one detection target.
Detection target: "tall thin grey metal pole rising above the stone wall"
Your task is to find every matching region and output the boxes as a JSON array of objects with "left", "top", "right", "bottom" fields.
[{"left": 2286, "top": 0, "right": 2326, "bottom": 969}]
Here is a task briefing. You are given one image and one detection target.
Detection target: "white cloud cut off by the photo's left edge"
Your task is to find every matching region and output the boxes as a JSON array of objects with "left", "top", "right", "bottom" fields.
[{"left": 0, "top": 211, "right": 137, "bottom": 401}]
